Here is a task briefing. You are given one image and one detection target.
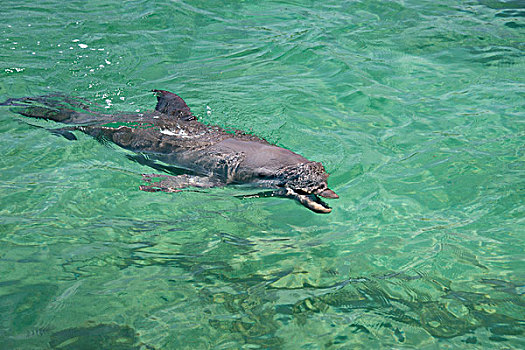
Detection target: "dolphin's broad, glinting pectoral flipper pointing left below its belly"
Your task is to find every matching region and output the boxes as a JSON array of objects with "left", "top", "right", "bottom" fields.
[{"left": 139, "top": 174, "right": 224, "bottom": 192}]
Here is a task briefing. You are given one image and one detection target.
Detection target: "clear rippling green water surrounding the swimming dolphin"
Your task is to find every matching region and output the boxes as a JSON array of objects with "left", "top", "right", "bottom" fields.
[{"left": 0, "top": 0, "right": 525, "bottom": 349}]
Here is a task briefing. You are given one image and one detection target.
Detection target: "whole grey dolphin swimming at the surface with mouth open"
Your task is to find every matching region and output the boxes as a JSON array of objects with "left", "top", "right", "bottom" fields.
[{"left": 0, "top": 90, "right": 338, "bottom": 213}]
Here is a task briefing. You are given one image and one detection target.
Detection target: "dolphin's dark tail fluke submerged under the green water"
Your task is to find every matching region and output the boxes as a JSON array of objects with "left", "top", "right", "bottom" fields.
[{"left": 0, "top": 95, "right": 100, "bottom": 125}]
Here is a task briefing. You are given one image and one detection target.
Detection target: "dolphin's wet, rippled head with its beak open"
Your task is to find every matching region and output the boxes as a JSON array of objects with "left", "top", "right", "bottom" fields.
[{"left": 282, "top": 162, "right": 339, "bottom": 213}]
